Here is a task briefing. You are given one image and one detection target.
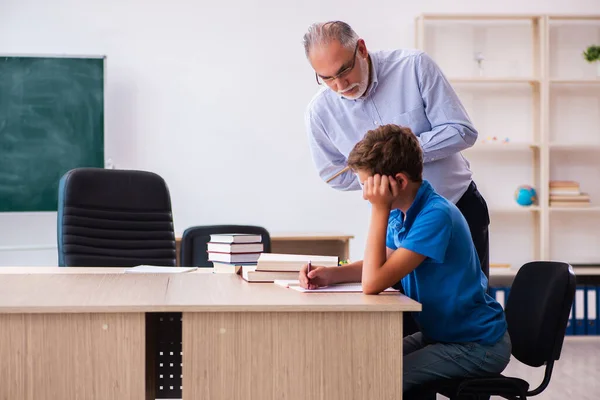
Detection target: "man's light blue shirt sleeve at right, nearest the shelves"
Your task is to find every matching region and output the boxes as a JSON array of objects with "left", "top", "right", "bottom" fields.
[{"left": 416, "top": 53, "right": 478, "bottom": 162}]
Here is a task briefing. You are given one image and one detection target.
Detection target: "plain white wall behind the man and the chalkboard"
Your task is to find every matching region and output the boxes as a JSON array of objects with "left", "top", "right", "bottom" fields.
[{"left": 0, "top": 0, "right": 600, "bottom": 265}]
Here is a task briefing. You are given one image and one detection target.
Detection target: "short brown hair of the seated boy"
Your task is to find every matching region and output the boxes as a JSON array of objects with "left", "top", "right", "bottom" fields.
[{"left": 348, "top": 124, "right": 423, "bottom": 182}]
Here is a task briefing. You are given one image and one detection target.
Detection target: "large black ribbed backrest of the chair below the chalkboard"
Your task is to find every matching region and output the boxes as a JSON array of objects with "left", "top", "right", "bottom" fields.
[{"left": 58, "top": 168, "right": 177, "bottom": 267}]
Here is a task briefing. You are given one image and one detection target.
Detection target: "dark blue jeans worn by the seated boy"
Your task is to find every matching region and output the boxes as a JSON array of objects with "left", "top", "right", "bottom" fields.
[{"left": 402, "top": 332, "right": 512, "bottom": 400}]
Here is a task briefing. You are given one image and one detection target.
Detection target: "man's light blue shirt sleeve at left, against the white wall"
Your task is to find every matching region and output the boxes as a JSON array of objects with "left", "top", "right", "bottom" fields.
[{"left": 305, "top": 110, "right": 361, "bottom": 190}]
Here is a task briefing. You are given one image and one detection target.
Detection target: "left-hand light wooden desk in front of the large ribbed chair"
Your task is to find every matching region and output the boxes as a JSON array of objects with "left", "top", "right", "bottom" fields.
[{"left": 0, "top": 268, "right": 169, "bottom": 400}]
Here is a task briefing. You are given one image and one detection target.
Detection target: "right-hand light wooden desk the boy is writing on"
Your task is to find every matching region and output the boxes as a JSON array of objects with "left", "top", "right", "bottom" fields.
[{"left": 167, "top": 274, "right": 420, "bottom": 400}]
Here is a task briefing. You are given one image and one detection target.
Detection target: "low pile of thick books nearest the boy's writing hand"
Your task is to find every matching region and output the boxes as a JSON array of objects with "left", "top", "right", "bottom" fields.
[{"left": 241, "top": 253, "right": 338, "bottom": 282}]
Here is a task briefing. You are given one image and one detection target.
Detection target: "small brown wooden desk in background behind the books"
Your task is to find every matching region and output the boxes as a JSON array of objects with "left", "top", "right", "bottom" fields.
[{"left": 176, "top": 233, "right": 354, "bottom": 265}]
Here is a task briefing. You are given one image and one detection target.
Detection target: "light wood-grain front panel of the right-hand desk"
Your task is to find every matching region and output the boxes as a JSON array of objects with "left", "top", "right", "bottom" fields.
[{"left": 183, "top": 312, "right": 402, "bottom": 400}]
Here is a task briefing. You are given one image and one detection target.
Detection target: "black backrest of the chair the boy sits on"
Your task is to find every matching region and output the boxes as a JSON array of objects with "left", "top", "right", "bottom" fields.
[{"left": 506, "top": 261, "right": 575, "bottom": 367}]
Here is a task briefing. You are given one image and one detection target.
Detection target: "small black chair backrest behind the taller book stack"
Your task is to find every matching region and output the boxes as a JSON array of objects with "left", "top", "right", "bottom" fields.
[{"left": 179, "top": 225, "right": 271, "bottom": 267}]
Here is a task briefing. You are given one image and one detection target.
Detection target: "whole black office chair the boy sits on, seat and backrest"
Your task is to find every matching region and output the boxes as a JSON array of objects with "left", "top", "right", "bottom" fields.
[{"left": 407, "top": 261, "right": 576, "bottom": 400}]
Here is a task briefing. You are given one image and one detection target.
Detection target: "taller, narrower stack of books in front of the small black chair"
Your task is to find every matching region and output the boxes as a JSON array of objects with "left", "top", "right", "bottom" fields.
[{"left": 206, "top": 233, "right": 264, "bottom": 274}]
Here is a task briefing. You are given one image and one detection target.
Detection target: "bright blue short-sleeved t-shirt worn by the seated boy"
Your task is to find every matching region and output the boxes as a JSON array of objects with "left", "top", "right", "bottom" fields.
[{"left": 386, "top": 180, "right": 506, "bottom": 344}]
